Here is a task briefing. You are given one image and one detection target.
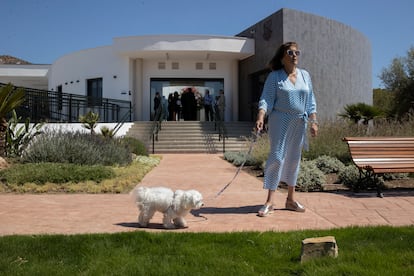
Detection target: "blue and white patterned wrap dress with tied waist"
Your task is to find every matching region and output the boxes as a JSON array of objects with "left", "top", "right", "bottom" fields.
[{"left": 259, "top": 68, "right": 316, "bottom": 190}]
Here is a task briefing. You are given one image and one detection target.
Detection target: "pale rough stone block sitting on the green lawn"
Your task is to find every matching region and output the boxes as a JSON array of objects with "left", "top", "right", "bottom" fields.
[{"left": 300, "top": 236, "right": 338, "bottom": 262}]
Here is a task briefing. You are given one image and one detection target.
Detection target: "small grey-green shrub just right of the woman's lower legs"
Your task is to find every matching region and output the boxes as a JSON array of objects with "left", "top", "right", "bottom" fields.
[{"left": 296, "top": 161, "right": 326, "bottom": 192}]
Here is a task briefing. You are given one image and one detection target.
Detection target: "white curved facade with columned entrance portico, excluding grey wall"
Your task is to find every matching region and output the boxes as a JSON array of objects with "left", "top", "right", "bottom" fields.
[{"left": 48, "top": 35, "right": 254, "bottom": 121}]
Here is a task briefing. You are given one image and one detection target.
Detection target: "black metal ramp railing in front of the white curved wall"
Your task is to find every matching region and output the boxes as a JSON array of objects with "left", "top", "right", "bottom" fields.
[{"left": 0, "top": 83, "right": 132, "bottom": 123}]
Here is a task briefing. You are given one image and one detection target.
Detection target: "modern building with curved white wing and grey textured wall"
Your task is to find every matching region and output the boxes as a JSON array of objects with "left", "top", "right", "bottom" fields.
[{"left": 0, "top": 9, "right": 372, "bottom": 121}]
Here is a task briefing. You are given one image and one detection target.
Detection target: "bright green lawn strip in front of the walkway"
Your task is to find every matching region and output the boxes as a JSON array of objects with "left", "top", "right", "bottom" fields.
[{"left": 0, "top": 226, "right": 414, "bottom": 275}]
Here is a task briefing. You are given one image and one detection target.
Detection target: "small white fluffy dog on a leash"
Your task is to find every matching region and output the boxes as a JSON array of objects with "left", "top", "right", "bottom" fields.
[{"left": 133, "top": 187, "right": 204, "bottom": 229}]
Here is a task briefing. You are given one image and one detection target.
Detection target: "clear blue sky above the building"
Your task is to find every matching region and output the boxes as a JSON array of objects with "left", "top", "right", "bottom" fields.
[{"left": 0, "top": 0, "right": 414, "bottom": 88}]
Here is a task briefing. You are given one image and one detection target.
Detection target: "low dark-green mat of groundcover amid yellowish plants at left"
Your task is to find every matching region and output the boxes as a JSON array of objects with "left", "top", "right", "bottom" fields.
[{"left": 0, "top": 163, "right": 115, "bottom": 185}]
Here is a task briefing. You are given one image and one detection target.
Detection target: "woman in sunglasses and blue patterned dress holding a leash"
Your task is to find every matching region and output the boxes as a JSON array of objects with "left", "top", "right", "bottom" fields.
[{"left": 256, "top": 42, "right": 318, "bottom": 217}]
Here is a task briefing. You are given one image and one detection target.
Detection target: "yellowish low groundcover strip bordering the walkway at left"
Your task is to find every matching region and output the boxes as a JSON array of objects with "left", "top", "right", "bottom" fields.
[{"left": 0, "top": 156, "right": 160, "bottom": 193}]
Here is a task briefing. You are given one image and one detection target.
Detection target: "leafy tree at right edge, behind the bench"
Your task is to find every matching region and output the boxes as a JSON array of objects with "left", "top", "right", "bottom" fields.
[{"left": 380, "top": 47, "right": 414, "bottom": 118}]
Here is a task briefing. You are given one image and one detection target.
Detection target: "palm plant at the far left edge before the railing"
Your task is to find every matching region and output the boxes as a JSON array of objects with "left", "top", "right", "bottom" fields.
[{"left": 0, "top": 83, "right": 25, "bottom": 157}]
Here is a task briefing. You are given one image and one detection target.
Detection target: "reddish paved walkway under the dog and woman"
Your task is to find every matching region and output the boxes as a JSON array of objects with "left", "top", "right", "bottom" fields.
[{"left": 0, "top": 154, "right": 414, "bottom": 236}]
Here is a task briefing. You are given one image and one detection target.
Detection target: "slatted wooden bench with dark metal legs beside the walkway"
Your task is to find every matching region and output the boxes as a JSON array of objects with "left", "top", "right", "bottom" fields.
[{"left": 343, "top": 137, "right": 414, "bottom": 197}]
